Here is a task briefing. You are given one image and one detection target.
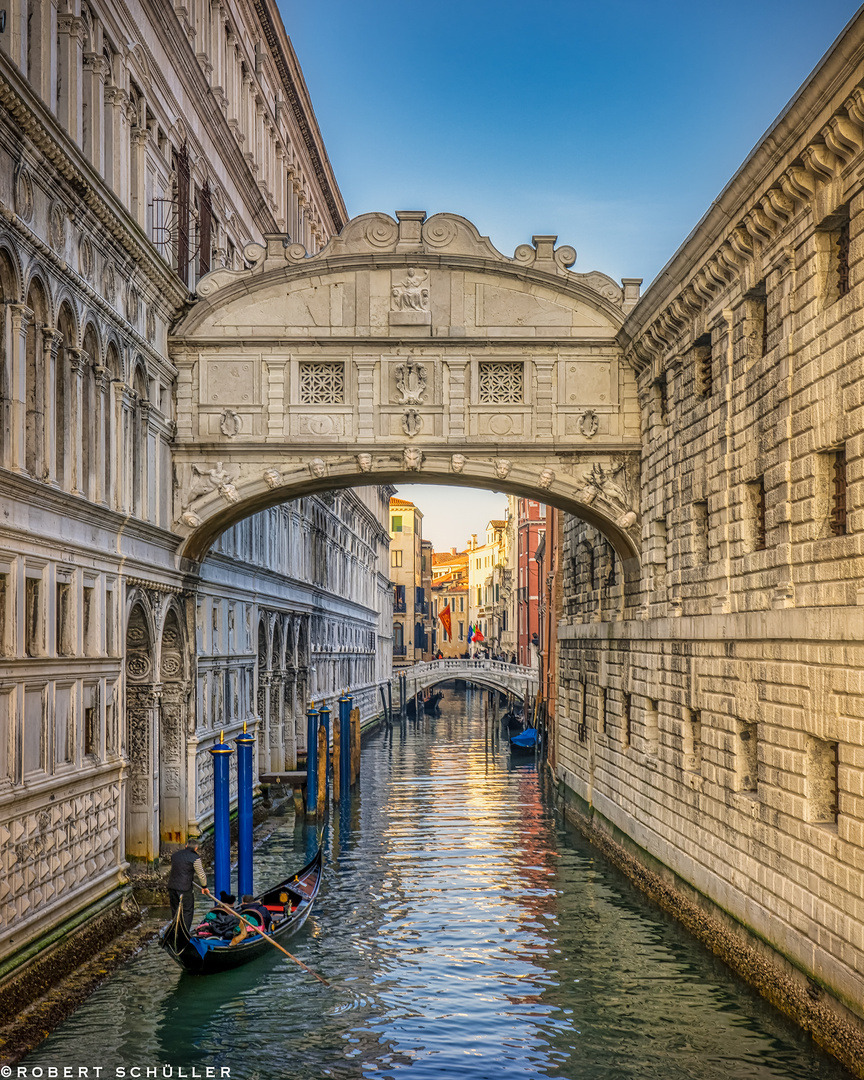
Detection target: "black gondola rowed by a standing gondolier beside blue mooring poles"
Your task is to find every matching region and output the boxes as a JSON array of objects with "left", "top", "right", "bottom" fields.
[{"left": 159, "top": 848, "right": 323, "bottom": 975}]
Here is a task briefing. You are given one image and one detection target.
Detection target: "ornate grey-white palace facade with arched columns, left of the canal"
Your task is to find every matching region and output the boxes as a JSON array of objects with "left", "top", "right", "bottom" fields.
[{"left": 0, "top": 0, "right": 392, "bottom": 956}]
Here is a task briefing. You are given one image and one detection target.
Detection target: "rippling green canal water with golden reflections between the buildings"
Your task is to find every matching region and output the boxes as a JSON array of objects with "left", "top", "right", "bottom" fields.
[{"left": 23, "top": 691, "right": 849, "bottom": 1080}]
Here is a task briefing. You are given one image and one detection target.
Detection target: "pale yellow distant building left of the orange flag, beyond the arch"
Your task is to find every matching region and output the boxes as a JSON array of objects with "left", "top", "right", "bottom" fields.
[{"left": 390, "top": 497, "right": 432, "bottom": 666}]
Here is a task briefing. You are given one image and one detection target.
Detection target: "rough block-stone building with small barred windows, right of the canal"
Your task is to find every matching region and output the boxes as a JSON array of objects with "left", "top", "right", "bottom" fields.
[{"left": 557, "top": 13, "right": 864, "bottom": 1054}]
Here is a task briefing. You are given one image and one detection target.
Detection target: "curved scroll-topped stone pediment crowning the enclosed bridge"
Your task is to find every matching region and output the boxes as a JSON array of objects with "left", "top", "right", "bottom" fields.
[{"left": 182, "top": 211, "right": 629, "bottom": 339}]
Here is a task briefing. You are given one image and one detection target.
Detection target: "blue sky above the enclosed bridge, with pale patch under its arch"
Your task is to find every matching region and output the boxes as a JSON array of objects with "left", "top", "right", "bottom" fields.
[{"left": 281, "top": 0, "right": 856, "bottom": 549}]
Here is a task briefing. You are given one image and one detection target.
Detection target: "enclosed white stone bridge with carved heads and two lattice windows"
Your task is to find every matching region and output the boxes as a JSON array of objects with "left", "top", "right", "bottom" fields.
[{"left": 168, "top": 212, "right": 640, "bottom": 583}]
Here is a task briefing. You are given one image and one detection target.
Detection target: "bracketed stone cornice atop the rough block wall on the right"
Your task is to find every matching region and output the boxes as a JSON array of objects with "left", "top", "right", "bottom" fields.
[{"left": 618, "top": 25, "right": 864, "bottom": 374}]
